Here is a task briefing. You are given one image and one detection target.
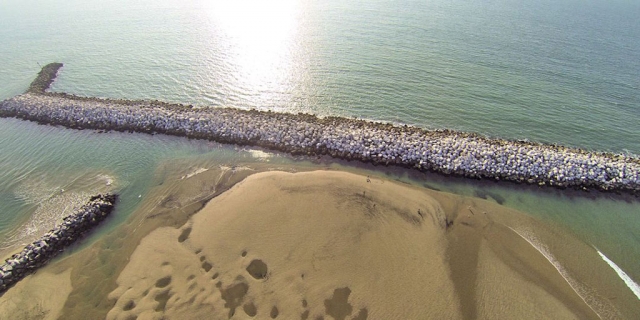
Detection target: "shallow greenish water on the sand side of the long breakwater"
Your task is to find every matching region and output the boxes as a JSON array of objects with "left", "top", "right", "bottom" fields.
[{"left": 0, "top": 119, "right": 640, "bottom": 298}]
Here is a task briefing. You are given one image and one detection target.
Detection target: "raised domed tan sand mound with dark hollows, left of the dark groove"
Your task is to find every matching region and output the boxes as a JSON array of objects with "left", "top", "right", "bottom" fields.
[{"left": 108, "top": 172, "right": 458, "bottom": 319}]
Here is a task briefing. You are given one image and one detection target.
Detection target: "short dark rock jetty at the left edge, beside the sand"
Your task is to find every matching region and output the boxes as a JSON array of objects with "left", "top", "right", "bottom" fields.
[{"left": 0, "top": 194, "right": 117, "bottom": 294}]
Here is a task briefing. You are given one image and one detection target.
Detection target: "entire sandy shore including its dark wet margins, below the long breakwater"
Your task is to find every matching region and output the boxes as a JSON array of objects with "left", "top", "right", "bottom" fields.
[{"left": 0, "top": 169, "right": 638, "bottom": 319}]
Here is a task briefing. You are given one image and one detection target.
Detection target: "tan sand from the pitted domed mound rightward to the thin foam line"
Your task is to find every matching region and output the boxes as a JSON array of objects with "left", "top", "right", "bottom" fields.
[{"left": 107, "top": 171, "right": 596, "bottom": 320}]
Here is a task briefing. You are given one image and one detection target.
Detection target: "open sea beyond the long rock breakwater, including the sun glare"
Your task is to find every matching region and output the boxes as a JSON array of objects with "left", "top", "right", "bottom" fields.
[{"left": 0, "top": 0, "right": 640, "bottom": 154}]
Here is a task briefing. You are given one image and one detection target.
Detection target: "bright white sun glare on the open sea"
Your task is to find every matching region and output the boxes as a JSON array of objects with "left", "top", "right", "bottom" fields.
[{"left": 207, "top": 0, "right": 300, "bottom": 108}]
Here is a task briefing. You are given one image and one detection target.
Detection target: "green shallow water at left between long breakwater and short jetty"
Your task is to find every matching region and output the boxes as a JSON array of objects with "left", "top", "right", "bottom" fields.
[{"left": 0, "top": 119, "right": 296, "bottom": 247}]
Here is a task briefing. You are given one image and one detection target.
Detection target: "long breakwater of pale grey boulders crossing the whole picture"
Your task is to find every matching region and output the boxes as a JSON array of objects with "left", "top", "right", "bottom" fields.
[{"left": 0, "top": 65, "right": 640, "bottom": 194}]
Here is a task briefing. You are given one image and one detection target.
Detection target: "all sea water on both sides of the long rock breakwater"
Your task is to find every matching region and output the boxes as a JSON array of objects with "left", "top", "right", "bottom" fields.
[{"left": 0, "top": 0, "right": 640, "bottom": 312}]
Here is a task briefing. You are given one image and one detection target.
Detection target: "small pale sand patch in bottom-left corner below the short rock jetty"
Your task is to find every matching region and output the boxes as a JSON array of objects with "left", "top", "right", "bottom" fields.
[{"left": 0, "top": 269, "right": 72, "bottom": 320}]
